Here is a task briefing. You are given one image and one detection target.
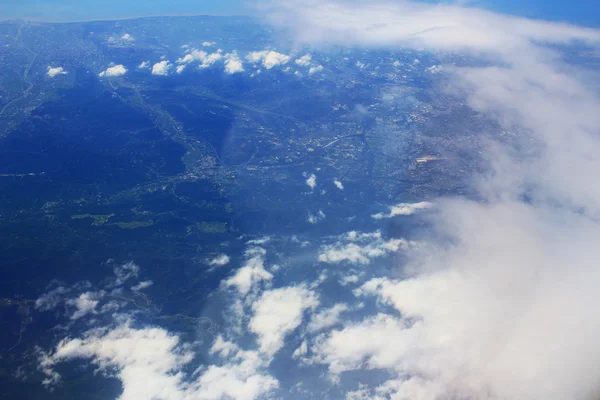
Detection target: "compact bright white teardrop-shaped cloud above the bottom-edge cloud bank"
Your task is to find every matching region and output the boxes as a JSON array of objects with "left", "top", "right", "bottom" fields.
[{"left": 248, "top": 286, "right": 319, "bottom": 356}]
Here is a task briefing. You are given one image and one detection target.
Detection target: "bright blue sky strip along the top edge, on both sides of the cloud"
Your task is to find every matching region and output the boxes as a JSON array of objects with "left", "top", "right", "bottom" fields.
[{"left": 0, "top": 0, "right": 600, "bottom": 27}]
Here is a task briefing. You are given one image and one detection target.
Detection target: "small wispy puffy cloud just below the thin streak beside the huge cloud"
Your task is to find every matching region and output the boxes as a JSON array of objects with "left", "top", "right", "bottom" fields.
[{"left": 319, "top": 231, "right": 409, "bottom": 264}]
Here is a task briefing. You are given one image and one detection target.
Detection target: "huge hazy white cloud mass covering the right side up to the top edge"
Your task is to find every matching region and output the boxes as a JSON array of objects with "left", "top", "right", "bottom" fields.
[{"left": 268, "top": 1, "right": 600, "bottom": 400}]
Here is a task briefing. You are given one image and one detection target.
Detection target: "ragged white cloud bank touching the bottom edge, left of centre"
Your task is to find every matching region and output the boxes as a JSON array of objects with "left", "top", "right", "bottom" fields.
[{"left": 40, "top": 320, "right": 278, "bottom": 400}]
